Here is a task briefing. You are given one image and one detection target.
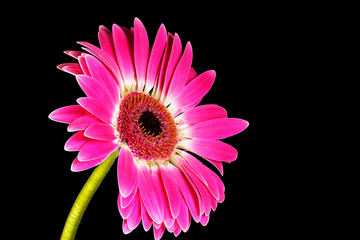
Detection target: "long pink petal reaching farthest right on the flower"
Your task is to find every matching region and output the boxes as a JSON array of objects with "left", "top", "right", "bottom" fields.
[{"left": 186, "top": 118, "right": 249, "bottom": 140}]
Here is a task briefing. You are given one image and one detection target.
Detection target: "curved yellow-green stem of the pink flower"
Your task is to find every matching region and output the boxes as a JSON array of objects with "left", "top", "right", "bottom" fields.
[{"left": 60, "top": 150, "right": 119, "bottom": 240}]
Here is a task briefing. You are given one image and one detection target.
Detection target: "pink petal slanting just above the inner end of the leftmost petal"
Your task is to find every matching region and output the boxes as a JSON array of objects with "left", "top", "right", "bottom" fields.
[{"left": 77, "top": 97, "right": 114, "bottom": 124}]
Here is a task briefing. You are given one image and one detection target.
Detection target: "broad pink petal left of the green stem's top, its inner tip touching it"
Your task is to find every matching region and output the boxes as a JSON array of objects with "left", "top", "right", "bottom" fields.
[{"left": 79, "top": 140, "right": 119, "bottom": 161}]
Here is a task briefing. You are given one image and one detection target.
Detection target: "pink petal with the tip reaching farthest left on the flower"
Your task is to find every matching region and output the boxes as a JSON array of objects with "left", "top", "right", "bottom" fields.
[{"left": 49, "top": 105, "right": 89, "bottom": 123}]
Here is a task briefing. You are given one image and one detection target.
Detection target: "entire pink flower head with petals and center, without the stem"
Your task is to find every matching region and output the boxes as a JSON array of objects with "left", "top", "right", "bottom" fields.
[{"left": 49, "top": 18, "right": 248, "bottom": 239}]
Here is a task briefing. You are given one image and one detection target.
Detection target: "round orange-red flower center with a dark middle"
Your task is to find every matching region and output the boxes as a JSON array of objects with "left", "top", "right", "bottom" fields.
[{"left": 117, "top": 92, "right": 178, "bottom": 161}]
